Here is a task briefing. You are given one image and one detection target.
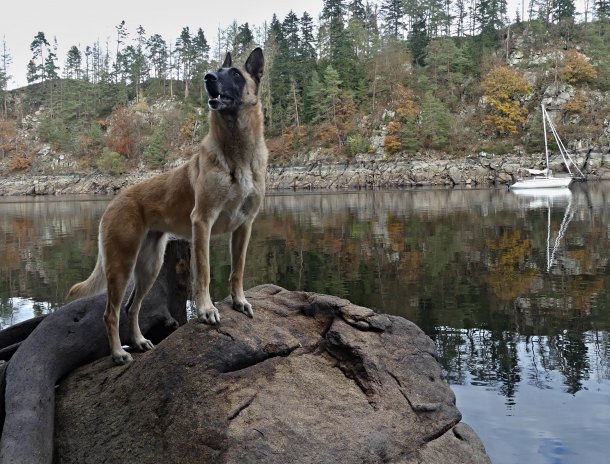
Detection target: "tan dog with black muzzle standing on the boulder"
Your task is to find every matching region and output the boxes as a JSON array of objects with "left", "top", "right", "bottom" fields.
[{"left": 68, "top": 48, "right": 268, "bottom": 364}]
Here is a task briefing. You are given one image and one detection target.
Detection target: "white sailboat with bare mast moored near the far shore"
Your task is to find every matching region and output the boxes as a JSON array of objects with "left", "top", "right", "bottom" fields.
[{"left": 510, "top": 105, "right": 585, "bottom": 190}]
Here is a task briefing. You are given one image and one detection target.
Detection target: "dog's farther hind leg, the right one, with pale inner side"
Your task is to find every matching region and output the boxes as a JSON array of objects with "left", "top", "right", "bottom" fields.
[{"left": 126, "top": 232, "right": 167, "bottom": 351}]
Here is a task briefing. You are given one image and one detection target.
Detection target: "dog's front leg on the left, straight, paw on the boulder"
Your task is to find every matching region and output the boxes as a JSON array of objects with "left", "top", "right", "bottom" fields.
[{"left": 191, "top": 212, "right": 220, "bottom": 324}]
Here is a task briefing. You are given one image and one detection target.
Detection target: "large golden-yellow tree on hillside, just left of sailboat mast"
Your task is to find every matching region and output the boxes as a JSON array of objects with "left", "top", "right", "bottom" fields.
[{"left": 482, "top": 66, "right": 532, "bottom": 135}]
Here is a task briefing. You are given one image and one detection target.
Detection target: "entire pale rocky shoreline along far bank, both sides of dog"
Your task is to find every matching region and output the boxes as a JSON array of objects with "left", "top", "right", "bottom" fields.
[{"left": 0, "top": 148, "right": 610, "bottom": 195}]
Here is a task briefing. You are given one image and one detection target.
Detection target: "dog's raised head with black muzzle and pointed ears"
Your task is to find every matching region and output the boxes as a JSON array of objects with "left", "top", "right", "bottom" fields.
[{"left": 203, "top": 48, "right": 265, "bottom": 113}]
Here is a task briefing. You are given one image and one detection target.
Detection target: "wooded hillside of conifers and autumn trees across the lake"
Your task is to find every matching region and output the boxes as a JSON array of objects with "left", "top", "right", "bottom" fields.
[{"left": 0, "top": 0, "right": 610, "bottom": 174}]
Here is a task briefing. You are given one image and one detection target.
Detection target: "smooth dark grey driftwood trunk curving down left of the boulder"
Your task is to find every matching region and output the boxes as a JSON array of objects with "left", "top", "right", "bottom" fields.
[{"left": 0, "top": 241, "right": 190, "bottom": 464}]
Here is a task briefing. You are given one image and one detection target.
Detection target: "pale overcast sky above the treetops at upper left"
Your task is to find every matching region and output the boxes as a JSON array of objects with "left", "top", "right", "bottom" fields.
[{"left": 0, "top": 0, "right": 322, "bottom": 89}]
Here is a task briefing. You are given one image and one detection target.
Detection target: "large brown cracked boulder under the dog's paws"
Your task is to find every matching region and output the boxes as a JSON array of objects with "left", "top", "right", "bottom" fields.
[{"left": 55, "top": 285, "right": 490, "bottom": 464}]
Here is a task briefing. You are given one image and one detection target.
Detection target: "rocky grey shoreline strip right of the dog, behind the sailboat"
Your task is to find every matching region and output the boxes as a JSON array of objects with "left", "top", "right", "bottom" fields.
[{"left": 267, "top": 149, "right": 610, "bottom": 190}]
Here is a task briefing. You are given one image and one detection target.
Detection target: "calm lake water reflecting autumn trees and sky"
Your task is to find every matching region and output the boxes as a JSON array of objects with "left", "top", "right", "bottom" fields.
[{"left": 0, "top": 183, "right": 610, "bottom": 464}]
